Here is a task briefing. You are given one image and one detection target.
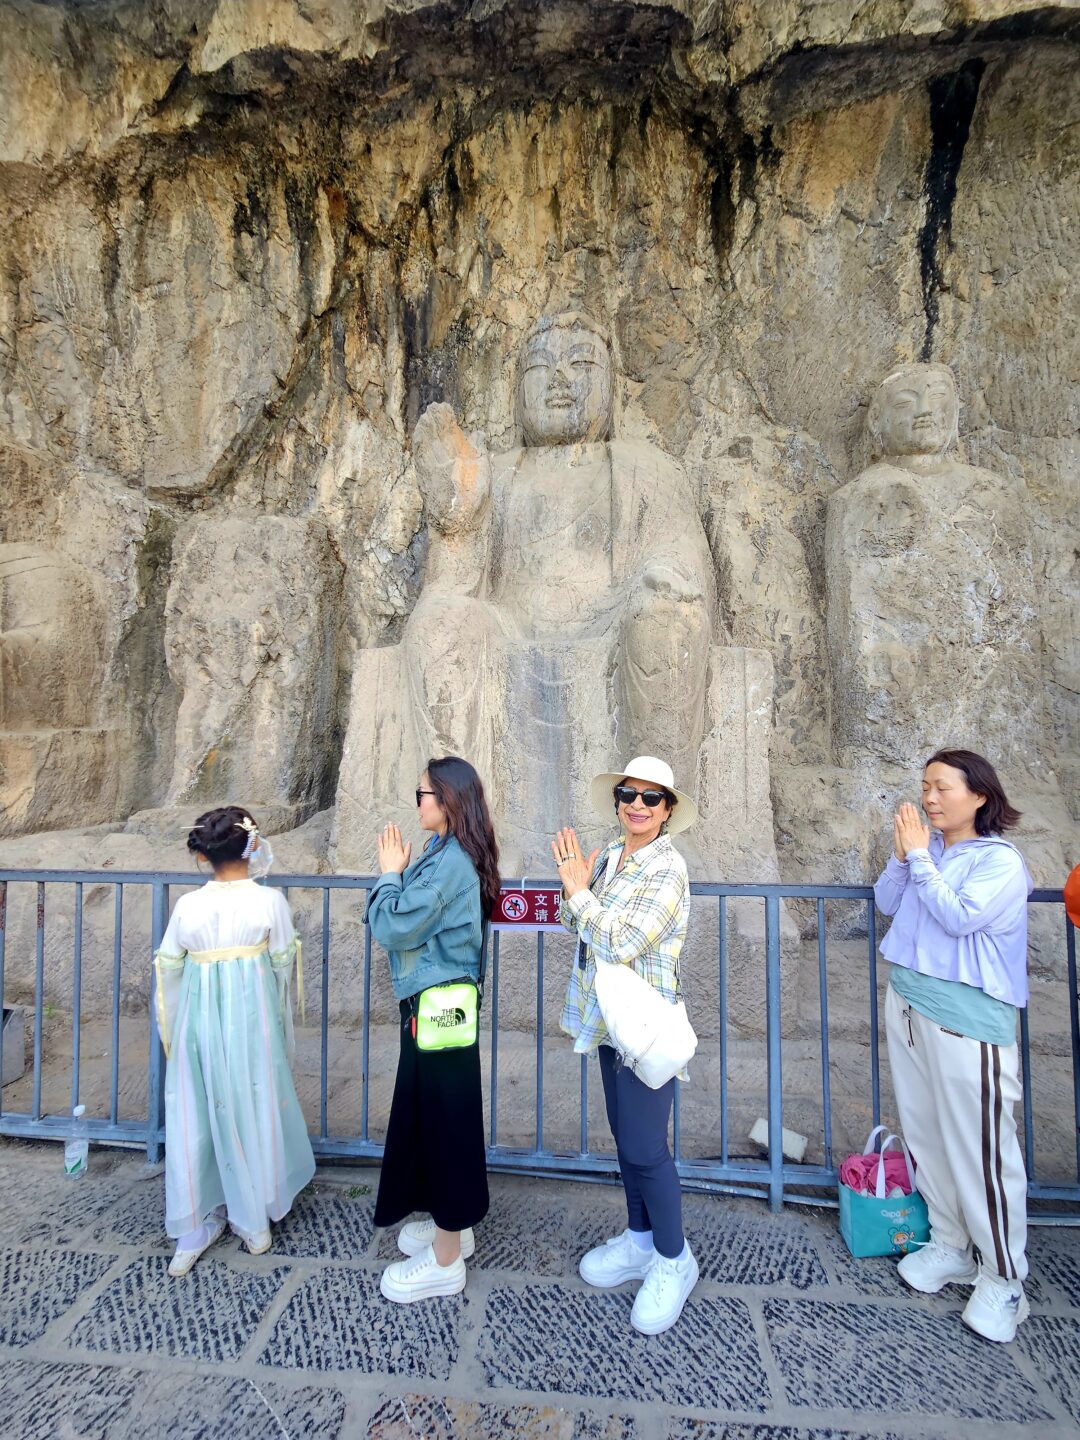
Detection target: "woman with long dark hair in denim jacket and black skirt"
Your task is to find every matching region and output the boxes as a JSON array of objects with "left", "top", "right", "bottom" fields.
[{"left": 366, "top": 755, "right": 500, "bottom": 1303}]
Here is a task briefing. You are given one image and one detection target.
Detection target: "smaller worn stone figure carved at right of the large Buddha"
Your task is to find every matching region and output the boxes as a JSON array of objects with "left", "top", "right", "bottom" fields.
[{"left": 827, "top": 364, "right": 1041, "bottom": 765}]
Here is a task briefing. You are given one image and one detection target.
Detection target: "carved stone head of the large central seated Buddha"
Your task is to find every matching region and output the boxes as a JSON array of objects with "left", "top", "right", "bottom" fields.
[{"left": 517, "top": 311, "right": 613, "bottom": 445}]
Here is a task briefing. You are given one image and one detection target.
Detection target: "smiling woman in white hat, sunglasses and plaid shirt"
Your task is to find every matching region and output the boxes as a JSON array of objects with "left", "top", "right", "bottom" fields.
[{"left": 552, "top": 755, "right": 697, "bottom": 1335}]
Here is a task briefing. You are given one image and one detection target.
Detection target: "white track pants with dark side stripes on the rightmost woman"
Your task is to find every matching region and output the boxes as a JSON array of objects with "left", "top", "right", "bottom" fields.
[{"left": 886, "top": 985, "right": 1028, "bottom": 1280}]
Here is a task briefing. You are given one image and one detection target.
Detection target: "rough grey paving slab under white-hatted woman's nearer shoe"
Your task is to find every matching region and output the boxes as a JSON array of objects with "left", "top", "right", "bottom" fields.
[{"left": 477, "top": 1284, "right": 769, "bottom": 1411}]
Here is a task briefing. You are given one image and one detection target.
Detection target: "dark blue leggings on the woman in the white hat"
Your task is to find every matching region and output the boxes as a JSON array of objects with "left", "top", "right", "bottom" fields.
[{"left": 600, "top": 1045, "right": 683, "bottom": 1260}]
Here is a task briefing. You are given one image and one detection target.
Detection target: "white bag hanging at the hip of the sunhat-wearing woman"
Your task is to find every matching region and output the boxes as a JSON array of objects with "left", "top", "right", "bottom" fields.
[{"left": 596, "top": 960, "right": 697, "bottom": 1090}]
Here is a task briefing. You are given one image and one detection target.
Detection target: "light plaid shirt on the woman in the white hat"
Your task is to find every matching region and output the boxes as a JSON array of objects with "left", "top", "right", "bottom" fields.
[{"left": 559, "top": 835, "right": 690, "bottom": 1054}]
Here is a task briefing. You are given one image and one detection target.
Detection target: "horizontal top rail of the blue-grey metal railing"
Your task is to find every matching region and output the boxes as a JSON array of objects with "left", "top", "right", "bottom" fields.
[{"left": 0, "top": 868, "right": 1063, "bottom": 904}]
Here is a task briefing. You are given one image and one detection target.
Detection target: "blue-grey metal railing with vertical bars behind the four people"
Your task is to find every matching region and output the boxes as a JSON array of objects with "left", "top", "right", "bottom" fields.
[{"left": 0, "top": 870, "right": 1080, "bottom": 1224}]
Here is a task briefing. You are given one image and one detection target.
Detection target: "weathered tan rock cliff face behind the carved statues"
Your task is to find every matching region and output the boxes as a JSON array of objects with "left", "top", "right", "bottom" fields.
[{"left": 0, "top": 0, "right": 1080, "bottom": 883}]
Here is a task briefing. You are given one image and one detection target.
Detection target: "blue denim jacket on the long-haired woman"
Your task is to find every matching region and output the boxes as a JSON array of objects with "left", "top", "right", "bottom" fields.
[{"left": 364, "top": 835, "right": 482, "bottom": 999}]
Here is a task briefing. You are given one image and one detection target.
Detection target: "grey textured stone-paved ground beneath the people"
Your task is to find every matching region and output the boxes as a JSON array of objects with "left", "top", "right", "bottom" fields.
[{"left": 0, "top": 1140, "right": 1080, "bottom": 1440}]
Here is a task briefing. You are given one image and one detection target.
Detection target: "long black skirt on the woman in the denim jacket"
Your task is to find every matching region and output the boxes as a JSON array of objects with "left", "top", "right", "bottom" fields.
[{"left": 374, "top": 1001, "right": 488, "bottom": 1230}]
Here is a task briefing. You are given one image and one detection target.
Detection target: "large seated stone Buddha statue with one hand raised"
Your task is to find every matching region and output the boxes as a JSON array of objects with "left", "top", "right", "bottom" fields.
[{"left": 360, "top": 312, "right": 716, "bottom": 854}]
